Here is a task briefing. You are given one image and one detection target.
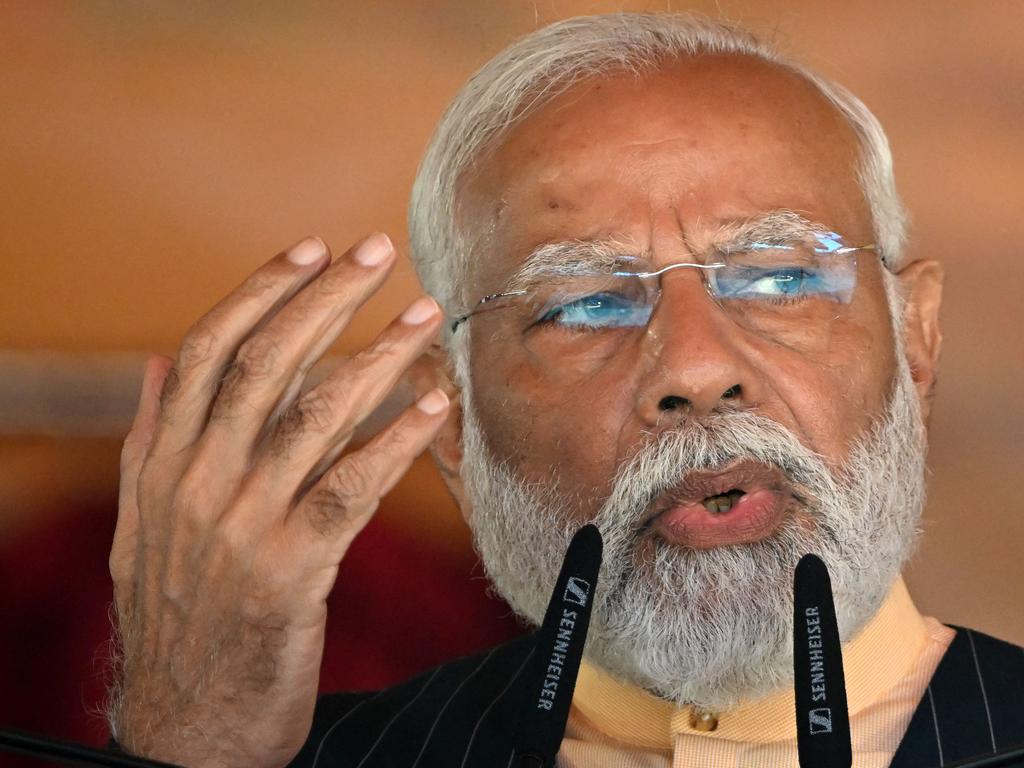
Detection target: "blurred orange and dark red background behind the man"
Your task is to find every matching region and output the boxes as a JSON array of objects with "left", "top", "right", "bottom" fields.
[{"left": 0, "top": 0, "right": 1024, "bottom": 742}]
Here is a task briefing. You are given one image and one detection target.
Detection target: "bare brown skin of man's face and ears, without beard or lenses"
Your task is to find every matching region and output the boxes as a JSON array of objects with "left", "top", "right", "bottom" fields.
[{"left": 423, "top": 56, "right": 941, "bottom": 518}]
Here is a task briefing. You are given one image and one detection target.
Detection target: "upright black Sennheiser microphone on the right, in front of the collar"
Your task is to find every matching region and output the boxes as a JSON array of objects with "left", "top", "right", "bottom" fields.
[{"left": 793, "top": 555, "right": 853, "bottom": 768}]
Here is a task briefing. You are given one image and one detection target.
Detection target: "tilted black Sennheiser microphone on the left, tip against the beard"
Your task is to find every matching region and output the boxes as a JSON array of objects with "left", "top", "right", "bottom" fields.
[{"left": 511, "top": 525, "right": 603, "bottom": 768}]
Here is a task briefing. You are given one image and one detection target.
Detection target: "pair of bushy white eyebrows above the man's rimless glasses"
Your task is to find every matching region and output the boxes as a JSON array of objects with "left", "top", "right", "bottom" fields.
[{"left": 506, "top": 209, "right": 830, "bottom": 292}]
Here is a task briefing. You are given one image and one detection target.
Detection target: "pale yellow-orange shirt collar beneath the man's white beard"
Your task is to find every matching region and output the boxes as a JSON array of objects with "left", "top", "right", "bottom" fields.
[{"left": 572, "top": 579, "right": 928, "bottom": 750}]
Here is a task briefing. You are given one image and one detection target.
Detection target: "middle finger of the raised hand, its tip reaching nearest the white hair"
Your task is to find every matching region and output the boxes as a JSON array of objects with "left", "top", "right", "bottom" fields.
[{"left": 190, "top": 234, "right": 394, "bottom": 483}]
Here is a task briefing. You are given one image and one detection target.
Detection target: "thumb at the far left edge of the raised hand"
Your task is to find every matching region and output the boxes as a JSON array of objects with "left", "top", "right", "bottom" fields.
[{"left": 110, "top": 355, "right": 174, "bottom": 608}]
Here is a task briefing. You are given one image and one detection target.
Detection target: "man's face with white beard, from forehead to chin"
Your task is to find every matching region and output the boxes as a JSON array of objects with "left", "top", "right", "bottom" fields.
[{"left": 435, "top": 57, "right": 938, "bottom": 708}]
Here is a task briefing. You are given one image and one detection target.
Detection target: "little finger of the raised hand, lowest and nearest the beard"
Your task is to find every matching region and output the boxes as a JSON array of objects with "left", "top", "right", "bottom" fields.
[{"left": 286, "top": 389, "right": 449, "bottom": 561}]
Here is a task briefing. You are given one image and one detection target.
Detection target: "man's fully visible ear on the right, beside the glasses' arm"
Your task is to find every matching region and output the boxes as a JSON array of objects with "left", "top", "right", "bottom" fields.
[{"left": 896, "top": 259, "right": 943, "bottom": 423}]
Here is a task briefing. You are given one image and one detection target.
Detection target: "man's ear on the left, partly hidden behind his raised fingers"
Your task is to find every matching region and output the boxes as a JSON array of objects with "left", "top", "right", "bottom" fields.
[{"left": 406, "top": 344, "right": 470, "bottom": 520}]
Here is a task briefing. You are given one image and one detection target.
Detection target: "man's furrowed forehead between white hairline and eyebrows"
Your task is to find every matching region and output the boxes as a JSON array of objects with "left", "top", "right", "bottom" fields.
[{"left": 464, "top": 51, "right": 870, "bottom": 287}]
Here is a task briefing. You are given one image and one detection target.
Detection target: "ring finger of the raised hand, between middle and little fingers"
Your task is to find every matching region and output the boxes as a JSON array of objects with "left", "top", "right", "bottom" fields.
[{"left": 252, "top": 297, "right": 441, "bottom": 509}]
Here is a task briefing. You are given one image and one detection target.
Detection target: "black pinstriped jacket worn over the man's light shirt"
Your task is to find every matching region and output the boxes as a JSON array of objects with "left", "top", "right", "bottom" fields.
[{"left": 290, "top": 627, "right": 1024, "bottom": 768}]
